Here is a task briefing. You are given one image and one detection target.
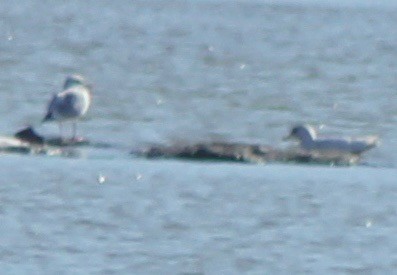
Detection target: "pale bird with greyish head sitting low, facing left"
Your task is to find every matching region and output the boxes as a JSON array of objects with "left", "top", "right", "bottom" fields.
[{"left": 284, "top": 125, "right": 379, "bottom": 155}]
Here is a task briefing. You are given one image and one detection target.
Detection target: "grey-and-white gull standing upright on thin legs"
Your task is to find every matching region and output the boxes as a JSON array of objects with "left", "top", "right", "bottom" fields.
[{"left": 43, "top": 75, "right": 91, "bottom": 141}]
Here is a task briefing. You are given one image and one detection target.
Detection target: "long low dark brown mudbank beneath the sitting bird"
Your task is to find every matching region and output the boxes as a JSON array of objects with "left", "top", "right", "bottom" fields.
[{"left": 138, "top": 143, "right": 359, "bottom": 165}]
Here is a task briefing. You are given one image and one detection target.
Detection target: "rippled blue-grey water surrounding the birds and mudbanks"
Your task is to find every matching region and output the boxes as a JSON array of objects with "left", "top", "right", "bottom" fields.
[{"left": 0, "top": 0, "right": 397, "bottom": 274}]
